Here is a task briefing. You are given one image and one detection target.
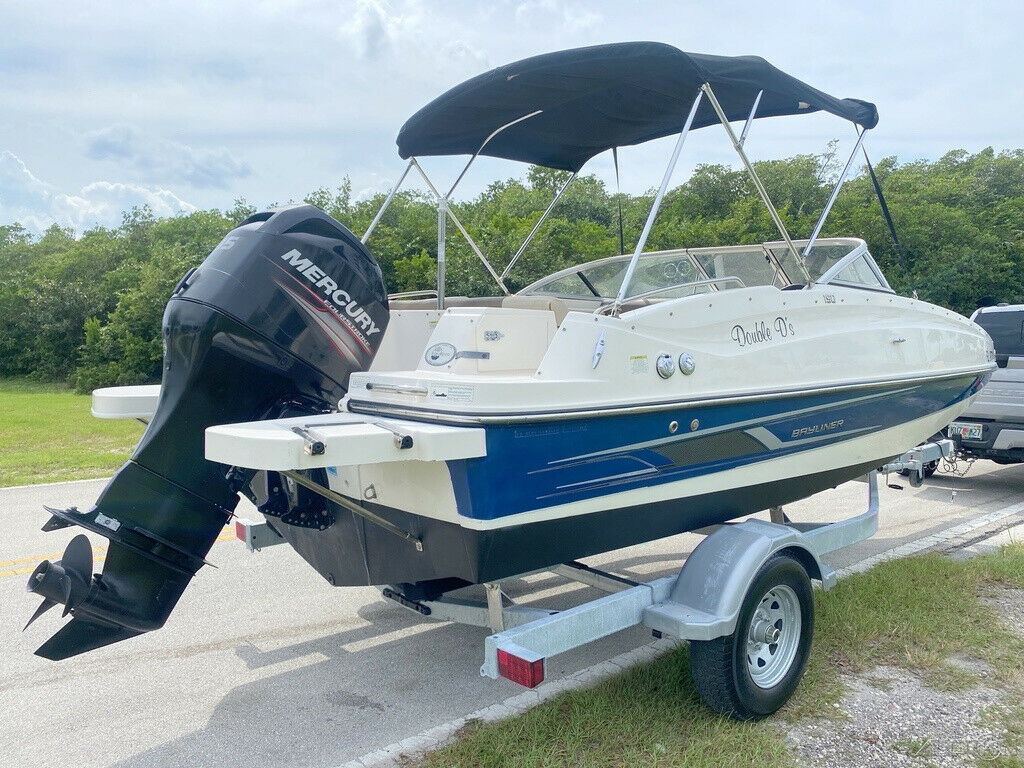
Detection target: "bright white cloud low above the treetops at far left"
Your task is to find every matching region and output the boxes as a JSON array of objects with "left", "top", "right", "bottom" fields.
[{"left": 0, "top": 152, "right": 196, "bottom": 233}]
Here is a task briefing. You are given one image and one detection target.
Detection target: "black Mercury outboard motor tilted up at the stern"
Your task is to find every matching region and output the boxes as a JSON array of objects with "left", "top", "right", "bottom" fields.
[{"left": 26, "top": 206, "right": 388, "bottom": 659}]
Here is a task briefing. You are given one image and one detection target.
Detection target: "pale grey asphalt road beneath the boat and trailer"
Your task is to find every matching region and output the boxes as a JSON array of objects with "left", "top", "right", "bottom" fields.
[{"left": 0, "top": 462, "right": 1024, "bottom": 768}]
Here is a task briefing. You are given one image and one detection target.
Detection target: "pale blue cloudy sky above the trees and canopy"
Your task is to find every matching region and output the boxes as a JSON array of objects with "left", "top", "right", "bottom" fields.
[{"left": 0, "top": 0, "right": 1024, "bottom": 233}]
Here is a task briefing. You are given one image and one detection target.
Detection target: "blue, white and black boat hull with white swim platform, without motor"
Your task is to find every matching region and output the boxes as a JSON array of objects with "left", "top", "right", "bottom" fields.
[{"left": 207, "top": 286, "right": 992, "bottom": 588}]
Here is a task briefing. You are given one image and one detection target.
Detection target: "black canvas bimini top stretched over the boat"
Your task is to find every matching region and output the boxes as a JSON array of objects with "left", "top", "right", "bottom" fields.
[{"left": 398, "top": 43, "right": 879, "bottom": 171}]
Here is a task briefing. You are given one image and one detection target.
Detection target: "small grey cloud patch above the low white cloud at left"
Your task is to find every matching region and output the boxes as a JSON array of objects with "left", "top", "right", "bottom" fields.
[{"left": 85, "top": 125, "right": 252, "bottom": 189}]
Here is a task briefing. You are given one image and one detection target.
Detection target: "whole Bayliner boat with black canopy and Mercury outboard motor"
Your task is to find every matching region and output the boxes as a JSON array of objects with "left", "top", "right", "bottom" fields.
[{"left": 29, "top": 43, "right": 995, "bottom": 659}]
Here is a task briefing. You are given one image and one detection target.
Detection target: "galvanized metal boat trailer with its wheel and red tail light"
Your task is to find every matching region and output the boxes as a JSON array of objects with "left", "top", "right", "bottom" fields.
[{"left": 236, "top": 440, "right": 953, "bottom": 719}]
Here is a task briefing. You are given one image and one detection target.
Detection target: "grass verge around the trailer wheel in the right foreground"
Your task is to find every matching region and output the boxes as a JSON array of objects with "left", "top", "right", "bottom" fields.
[{"left": 422, "top": 545, "right": 1024, "bottom": 768}]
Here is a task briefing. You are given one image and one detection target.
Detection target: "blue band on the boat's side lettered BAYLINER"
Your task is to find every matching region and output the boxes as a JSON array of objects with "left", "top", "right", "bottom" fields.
[{"left": 449, "top": 375, "right": 985, "bottom": 520}]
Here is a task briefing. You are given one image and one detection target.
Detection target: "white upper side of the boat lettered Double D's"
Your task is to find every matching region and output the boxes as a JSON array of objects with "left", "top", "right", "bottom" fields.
[{"left": 349, "top": 285, "right": 993, "bottom": 416}]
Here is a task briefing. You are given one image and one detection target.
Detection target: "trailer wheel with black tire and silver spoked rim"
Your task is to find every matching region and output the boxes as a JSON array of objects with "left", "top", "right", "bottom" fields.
[{"left": 690, "top": 555, "right": 814, "bottom": 720}]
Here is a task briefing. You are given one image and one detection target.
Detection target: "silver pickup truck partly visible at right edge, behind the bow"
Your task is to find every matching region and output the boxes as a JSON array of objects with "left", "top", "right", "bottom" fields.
[{"left": 947, "top": 304, "right": 1024, "bottom": 464}]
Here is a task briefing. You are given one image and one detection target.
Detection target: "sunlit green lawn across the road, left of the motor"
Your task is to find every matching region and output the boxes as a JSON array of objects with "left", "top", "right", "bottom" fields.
[{"left": 0, "top": 379, "right": 143, "bottom": 486}]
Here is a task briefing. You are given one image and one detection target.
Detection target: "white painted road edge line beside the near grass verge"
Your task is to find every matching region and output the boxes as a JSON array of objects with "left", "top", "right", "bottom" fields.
[{"left": 337, "top": 502, "right": 1024, "bottom": 768}]
